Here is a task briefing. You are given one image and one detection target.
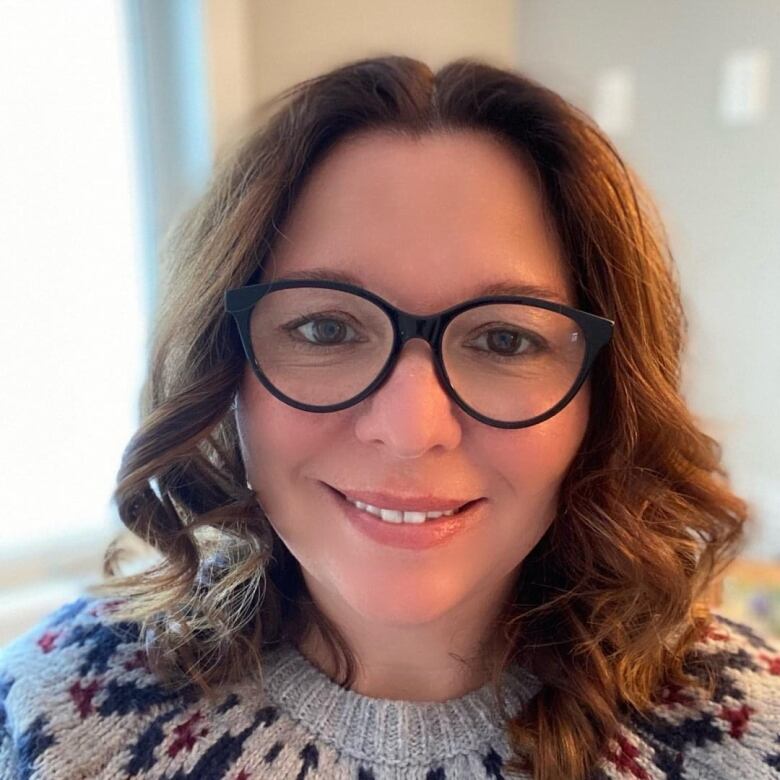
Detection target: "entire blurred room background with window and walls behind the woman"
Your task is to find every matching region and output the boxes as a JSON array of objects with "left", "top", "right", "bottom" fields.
[{"left": 0, "top": 0, "right": 780, "bottom": 644}]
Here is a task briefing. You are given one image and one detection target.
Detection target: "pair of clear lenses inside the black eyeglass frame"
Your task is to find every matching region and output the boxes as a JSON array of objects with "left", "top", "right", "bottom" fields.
[{"left": 250, "top": 287, "right": 586, "bottom": 423}]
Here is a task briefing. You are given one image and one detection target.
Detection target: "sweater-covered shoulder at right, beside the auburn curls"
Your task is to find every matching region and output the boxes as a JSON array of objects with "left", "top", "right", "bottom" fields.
[{"left": 611, "top": 613, "right": 780, "bottom": 780}]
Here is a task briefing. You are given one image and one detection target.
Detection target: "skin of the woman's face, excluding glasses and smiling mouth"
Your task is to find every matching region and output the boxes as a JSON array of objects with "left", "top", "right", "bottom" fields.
[{"left": 237, "top": 132, "right": 589, "bottom": 630}]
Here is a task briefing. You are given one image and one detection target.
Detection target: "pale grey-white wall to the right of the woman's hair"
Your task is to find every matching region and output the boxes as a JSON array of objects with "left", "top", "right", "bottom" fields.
[{"left": 515, "top": 0, "right": 780, "bottom": 560}]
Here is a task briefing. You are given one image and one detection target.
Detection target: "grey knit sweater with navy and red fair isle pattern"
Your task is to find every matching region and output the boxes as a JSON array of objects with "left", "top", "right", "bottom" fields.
[{"left": 0, "top": 597, "right": 780, "bottom": 780}]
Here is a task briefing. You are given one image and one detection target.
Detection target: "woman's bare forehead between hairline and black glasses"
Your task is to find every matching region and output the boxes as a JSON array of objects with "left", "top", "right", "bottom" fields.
[{"left": 263, "top": 132, "right": 573, "bottom": 311}]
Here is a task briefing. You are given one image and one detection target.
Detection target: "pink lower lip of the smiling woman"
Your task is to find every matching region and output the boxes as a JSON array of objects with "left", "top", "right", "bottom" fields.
[{"left": 322, "top": 482, "right": 487, "bottom": 550}]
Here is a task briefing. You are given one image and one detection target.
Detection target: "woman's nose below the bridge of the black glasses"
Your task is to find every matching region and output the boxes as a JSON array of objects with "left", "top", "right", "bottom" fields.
[{"left": 355, "top": 338, "right": 462, "bottom": 459}]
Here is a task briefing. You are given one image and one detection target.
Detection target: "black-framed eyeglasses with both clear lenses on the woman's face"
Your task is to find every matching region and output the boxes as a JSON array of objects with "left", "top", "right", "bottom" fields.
[{"left": 225, "top": 279, "right": 615, "bottom": 428}]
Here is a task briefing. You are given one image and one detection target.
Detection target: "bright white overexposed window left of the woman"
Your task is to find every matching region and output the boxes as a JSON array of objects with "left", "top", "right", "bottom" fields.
[{"left": 0, "top": 0, "right": 146, "bottom": 557}]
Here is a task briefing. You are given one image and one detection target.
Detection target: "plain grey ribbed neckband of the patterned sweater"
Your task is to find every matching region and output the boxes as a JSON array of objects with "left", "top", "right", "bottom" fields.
[{"left": 263, "top": 642, "right": 541, "bottom": 766}]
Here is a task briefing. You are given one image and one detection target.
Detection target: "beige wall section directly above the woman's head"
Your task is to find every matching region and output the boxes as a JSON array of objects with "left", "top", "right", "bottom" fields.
[{"left": 204, "top": 0, "right": 516, "bottom": 155}]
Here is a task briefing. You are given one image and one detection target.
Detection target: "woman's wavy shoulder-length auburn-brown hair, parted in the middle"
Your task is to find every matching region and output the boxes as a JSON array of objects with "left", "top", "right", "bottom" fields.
[{"left": 92, "top": 56, "right": 752, "bottom": 780}]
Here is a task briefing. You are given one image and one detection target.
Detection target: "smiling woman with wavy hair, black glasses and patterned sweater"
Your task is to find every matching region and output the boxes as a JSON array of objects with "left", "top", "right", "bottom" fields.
[{"left": 3, "top": 57, "right": 780, "bottom": 780}]
